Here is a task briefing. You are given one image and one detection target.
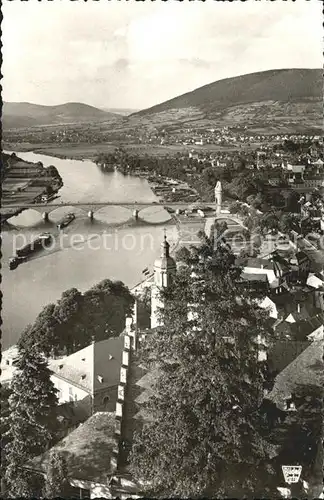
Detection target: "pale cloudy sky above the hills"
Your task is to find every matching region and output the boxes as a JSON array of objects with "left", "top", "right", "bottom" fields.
[{"left": 2, "top": 0, "right": 323, "bottom": 109}]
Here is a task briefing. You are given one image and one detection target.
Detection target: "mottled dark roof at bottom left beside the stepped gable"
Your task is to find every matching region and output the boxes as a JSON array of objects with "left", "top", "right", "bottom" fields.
[{"left": 28, "top": 412, "right": 115, "bottom": 483}]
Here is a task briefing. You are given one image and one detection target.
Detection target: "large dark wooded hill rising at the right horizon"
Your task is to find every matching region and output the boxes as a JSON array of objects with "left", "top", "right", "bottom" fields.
[{"left": 131, "top": 69, "right": 323, "bottom": 132}]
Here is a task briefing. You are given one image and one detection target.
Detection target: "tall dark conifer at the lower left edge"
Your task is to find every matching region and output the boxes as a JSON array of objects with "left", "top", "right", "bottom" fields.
[{"left": 5, "top": 348, "right": 57, "bottom": 497}]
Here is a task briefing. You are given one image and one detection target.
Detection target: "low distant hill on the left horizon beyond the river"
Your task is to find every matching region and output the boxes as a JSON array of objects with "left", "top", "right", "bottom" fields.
[{"left": 2, "top": 102, "right": 120, "bottom": 129}]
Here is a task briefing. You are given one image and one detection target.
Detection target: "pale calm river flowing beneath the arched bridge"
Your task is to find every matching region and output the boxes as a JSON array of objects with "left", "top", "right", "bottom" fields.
[{"left": 2, "top": 152, "right": 177, "bottom": 349}]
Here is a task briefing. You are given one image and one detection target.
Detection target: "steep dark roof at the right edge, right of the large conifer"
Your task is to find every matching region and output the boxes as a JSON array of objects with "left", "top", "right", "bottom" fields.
[{"left": 267, "top": 340, "right": 324, "bottom": 409}]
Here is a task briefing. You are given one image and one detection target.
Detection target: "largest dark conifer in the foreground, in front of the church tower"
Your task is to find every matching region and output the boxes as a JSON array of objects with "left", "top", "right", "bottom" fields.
[{"left": 131, "top": 243, "right": 275, "bottom": 497}]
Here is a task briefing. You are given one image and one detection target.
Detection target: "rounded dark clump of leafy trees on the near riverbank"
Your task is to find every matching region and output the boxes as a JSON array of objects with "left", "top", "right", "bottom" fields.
[{"left": 19, "top": 280, "right": 133, "bottom": 356}]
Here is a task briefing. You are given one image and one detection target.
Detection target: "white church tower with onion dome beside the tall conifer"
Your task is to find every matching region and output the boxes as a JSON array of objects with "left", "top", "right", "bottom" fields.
[{"left": 151, "top": 235, "right": 177, "bottom": 328}]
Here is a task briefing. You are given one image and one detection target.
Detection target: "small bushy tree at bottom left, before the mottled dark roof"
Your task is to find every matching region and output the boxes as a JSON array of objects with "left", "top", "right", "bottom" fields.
[{"left": 45, "top": 450, "right": 69, "bottom": 498}]
